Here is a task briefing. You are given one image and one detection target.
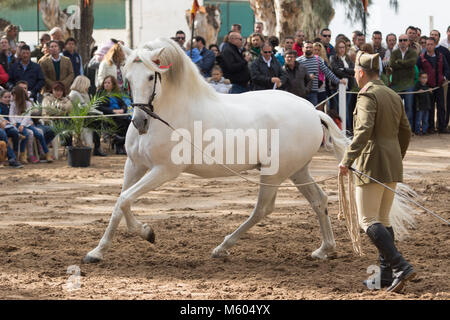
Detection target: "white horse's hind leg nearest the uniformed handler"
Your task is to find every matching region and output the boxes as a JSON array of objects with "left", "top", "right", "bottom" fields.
[{"left": 291, "top": 165, "right": 336, "bottom": 259}]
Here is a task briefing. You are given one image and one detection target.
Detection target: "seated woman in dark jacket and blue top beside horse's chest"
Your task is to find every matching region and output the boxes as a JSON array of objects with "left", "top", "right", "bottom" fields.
[{"left": 97, "top": 76, "right": 131, "bottom": 154}]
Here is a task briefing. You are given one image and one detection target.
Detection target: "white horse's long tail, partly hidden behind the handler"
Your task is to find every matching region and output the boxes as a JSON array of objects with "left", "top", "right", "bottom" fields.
[{"left": 317, "top": 111, "right": 419, "bottom": 240}]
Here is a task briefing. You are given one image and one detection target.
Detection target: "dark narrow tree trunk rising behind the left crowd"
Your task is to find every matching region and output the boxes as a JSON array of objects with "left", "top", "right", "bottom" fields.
[{"left": 71, "top": 0, "right": 95, "bottom": 64}]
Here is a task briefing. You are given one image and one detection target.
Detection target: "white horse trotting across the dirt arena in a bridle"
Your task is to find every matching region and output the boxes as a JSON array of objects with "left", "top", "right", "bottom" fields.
[{"left": 84, "top": 38, "right": 412, "bottom": 262}]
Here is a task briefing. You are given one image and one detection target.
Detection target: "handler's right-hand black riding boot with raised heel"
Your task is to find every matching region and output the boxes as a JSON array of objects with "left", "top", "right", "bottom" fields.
[{"left": 366, "top": 223, "right": 416, "bottom": 292}]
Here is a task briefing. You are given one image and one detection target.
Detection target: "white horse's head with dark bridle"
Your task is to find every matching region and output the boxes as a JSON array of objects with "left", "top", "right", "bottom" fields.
[{"left": 122, "top": 46, "right": 168, "bottom": 135}]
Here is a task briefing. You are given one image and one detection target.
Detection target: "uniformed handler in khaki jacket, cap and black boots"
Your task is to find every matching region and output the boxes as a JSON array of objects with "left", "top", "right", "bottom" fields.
[{"left": 339, "top": 51, "right": 415, "bottom": 292}]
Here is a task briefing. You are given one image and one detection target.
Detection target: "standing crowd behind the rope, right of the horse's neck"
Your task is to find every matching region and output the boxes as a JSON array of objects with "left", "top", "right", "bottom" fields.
[{"left": 177, "top": 22, "right": 450, "bottom": 135}]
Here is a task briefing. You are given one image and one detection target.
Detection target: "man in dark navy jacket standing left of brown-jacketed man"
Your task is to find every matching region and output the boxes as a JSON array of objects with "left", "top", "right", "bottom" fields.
[{"left": 8, "top": 45, "right": 45, "bottom": 101}]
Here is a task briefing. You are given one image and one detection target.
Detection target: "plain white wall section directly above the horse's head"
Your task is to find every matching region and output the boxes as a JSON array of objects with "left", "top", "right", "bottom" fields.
[{"left": 133, "top": 0, "right": 203, "bottom": 47}]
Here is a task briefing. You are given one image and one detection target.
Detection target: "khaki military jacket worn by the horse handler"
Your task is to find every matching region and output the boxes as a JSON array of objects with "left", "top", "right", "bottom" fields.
[{"left": 342, "top": 80, "right": 411, "bottom": 185}]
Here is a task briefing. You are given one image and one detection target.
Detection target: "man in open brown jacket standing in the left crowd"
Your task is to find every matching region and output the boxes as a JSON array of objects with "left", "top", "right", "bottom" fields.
[{"left": 40, "top": 40, "right": 74, "bottom": 94}]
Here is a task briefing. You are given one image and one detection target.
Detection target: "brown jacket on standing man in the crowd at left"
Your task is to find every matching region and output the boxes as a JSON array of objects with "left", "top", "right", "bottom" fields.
[{"left": 39, "top": 56, "right": 75, "bottom": 95}]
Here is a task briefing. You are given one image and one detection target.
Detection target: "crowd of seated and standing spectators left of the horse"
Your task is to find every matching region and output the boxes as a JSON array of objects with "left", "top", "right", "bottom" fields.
[{"left": 0, "top": 26, "right": 132, "bottom": 168}]
